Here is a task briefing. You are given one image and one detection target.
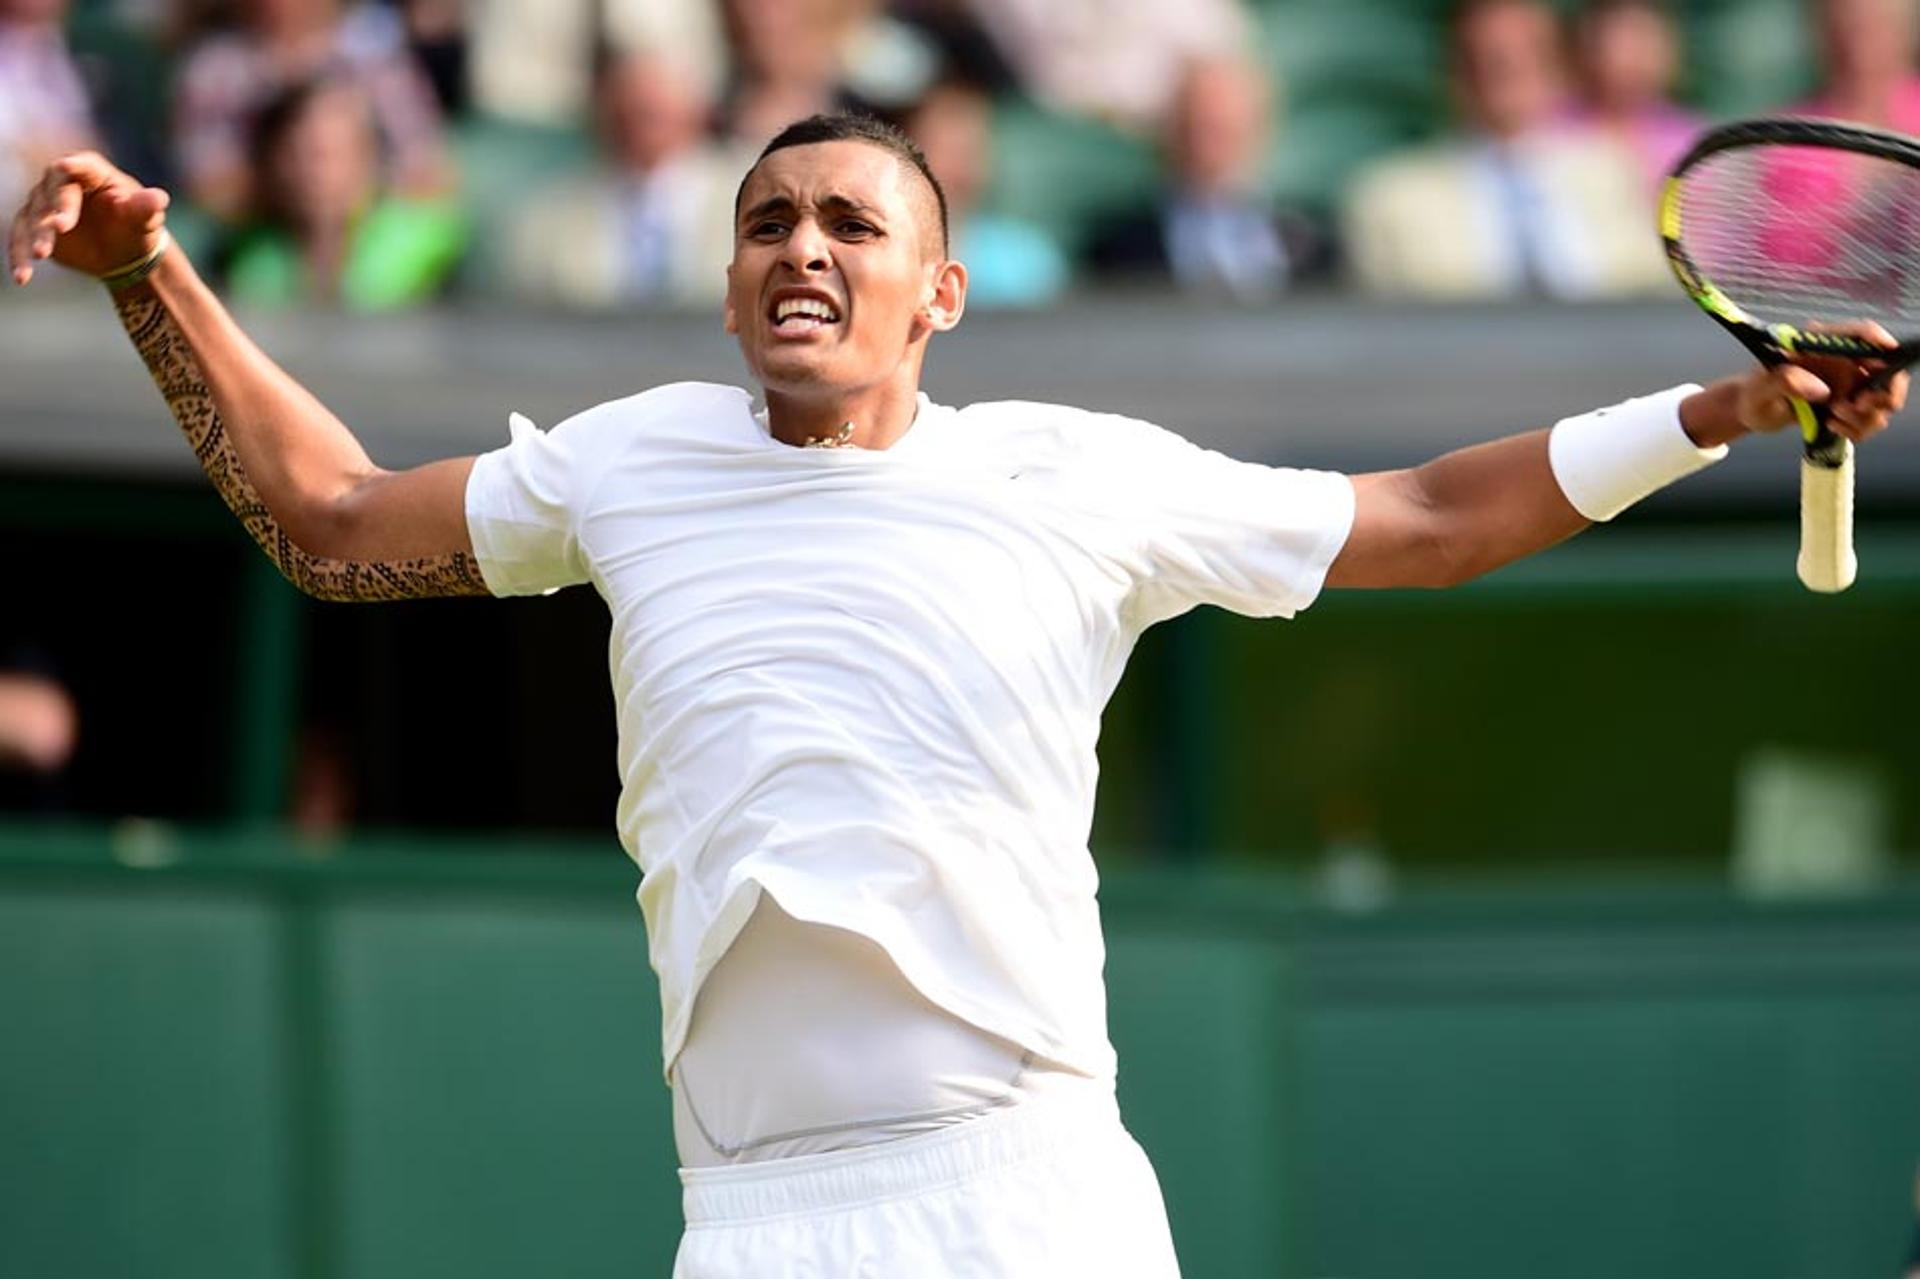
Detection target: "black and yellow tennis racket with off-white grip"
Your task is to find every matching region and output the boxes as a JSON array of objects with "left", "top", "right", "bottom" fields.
[{"left": 1661, "top": 119, "right": 1920, "bottom": 591}]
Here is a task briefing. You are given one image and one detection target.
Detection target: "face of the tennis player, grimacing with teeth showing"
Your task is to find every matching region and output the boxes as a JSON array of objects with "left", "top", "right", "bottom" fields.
[{"left": 726, "top": 142, "right": 960, "bottom": 394}]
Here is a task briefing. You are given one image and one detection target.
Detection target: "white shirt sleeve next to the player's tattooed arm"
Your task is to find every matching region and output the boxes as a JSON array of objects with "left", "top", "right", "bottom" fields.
[{"left": 467, "top": 413, "right": 591, "bottom": 595}]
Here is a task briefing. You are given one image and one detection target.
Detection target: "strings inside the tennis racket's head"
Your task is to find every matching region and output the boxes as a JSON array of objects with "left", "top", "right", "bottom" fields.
[{"left": 1680, "top": 146, "right": 1920, "bottom": 332}]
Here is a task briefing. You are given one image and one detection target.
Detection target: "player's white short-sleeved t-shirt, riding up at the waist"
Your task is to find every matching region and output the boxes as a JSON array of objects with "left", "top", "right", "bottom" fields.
[{"left": 467, "top": 382, "right": 1354, "bottom": 1077}]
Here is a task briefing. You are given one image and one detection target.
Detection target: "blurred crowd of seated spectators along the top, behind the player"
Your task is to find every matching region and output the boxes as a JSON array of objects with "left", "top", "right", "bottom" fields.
[{"left": 0, "top": 0, "right": 1920, "bottom": 309}]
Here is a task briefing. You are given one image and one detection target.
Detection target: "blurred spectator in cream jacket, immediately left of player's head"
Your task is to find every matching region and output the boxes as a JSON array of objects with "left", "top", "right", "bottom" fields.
[{"left": 501, "top": 54, "right": 751, "bottom": 309}]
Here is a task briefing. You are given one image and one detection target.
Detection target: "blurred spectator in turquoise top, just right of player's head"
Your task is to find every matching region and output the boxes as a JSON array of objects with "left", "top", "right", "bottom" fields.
[{"left": 906, "top": 81, "right": 1068, "bottom": 307}]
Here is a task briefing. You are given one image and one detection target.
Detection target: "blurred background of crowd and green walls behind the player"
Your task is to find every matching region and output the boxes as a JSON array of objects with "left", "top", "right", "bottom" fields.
[{"left": 0, "top": 0, "right": 1920, "bottom": 1279}]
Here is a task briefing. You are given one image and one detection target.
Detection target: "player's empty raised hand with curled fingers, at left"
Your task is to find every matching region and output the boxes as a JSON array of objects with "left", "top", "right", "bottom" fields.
[{"left": 6, "top": 152, "right": 169, "bottom": 284}]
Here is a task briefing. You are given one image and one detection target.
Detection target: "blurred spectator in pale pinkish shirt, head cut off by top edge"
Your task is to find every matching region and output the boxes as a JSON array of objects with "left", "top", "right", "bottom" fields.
[{"left": 973, "top": 0, "right": 1252, "bottom": 133}]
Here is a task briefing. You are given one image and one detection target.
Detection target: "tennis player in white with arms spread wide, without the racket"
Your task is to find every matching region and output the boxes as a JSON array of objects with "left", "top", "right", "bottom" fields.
[{"left": 8, "top": 117, "right": 1907, "bottom": 1279}]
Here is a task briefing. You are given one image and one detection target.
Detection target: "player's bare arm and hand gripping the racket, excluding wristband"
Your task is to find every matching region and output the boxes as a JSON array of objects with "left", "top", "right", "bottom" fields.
[{"left": 1327, "top": 353, "right": 1907, "bottom": 588}]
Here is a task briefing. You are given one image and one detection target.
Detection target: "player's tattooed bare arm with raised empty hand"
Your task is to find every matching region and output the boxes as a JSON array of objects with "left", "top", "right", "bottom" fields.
[{"left": 8, "top": 154, "right": 488, "bottom": 601}]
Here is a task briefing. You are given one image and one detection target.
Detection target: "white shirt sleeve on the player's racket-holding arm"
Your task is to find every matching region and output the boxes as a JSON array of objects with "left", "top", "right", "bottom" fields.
[{"left": 1102, "top": 419, "right": 1354, "bottom": 624}]
